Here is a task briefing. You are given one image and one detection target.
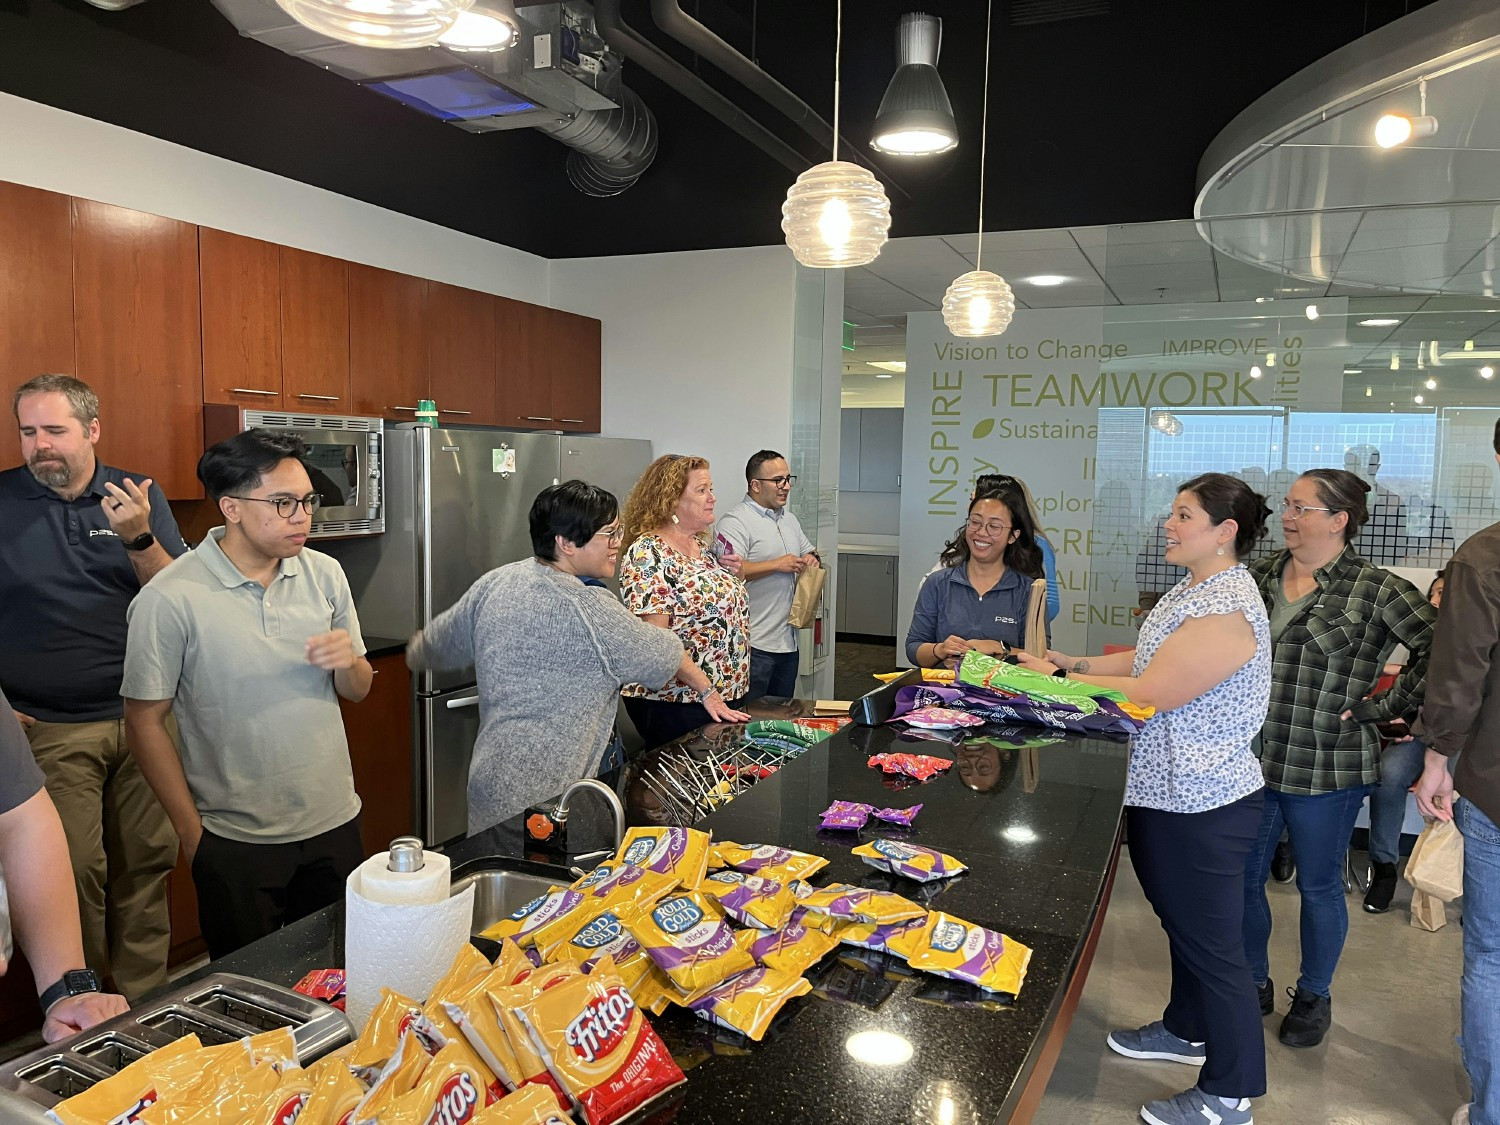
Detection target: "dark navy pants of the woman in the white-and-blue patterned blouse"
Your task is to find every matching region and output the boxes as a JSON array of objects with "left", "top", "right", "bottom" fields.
[{"left": 1125, "top": 792, "right": 1266, "bottom": 1098}]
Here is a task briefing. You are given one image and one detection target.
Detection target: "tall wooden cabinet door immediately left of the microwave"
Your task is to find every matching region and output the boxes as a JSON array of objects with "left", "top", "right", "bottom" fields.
[{"left": 74, "top": 200, "right": 203, "bottom": 500}]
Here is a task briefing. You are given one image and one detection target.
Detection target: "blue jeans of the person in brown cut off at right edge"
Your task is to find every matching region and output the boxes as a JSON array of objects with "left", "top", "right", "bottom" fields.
[{"left": 1454, "top": 801, "right": 1500, "bottom": 1125}]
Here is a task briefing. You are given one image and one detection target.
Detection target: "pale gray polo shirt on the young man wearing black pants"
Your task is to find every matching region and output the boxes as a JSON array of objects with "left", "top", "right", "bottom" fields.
[{"left": 120, "top": 528, "right": 365, "bottom": 843}]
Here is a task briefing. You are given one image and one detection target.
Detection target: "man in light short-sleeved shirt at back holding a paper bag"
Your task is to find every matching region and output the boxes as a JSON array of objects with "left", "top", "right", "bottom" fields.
[{"left": 714, "top": 449, "right": 818, "bottom": 699}]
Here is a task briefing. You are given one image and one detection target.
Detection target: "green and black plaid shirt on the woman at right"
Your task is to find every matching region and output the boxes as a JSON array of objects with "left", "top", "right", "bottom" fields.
[{"left": 1250, "top": 548, "right": 1437, "bottom": 795}]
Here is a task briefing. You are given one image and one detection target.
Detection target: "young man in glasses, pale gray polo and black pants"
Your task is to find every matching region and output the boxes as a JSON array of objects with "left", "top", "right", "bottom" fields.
[{"left": 120, "top": 429, "right": 374, "bottom": 957}]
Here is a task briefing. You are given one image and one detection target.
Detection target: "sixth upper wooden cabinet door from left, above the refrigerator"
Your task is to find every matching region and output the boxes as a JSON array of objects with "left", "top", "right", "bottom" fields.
[{"left": 428, "top": 282, "right": 501, "bottom": 426}]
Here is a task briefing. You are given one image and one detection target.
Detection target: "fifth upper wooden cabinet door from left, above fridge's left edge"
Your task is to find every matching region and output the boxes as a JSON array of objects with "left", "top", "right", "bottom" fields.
[{"left": 350, "top": 266, "right": 428, "bottom": 422}]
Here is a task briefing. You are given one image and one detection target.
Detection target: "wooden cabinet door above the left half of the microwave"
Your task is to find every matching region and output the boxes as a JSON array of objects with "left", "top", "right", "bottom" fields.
[{"left": 198, "top": 227, "right": 282, "bottom": 410}]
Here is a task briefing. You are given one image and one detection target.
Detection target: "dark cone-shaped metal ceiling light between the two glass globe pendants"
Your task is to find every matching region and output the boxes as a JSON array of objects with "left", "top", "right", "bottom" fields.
[{"left": 870, "top": 12, "right": 959, "bottom": 156}]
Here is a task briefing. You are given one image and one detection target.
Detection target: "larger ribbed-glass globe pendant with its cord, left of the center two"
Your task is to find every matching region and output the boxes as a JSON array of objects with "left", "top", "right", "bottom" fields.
[{"left": 782, "top": 0, "right": 891, "bottom": 270}]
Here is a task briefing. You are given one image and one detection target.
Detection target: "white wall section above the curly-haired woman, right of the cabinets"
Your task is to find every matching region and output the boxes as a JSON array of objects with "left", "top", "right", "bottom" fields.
[{"left": 551, "top": 246, "right": 804, "bottom": 486}]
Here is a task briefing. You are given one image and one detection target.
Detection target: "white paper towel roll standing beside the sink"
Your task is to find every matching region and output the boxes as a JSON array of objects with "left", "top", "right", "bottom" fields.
[{"left": 344, "top": 870, "right": 474, "bottom": 1031}]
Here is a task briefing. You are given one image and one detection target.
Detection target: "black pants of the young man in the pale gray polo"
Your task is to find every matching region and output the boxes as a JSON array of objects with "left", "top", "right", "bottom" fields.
[{"left": 192, "top": 816, "right": 365, "bottom": 959}]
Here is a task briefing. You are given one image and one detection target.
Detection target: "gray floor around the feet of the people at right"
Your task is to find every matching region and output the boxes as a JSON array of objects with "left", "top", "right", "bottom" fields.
[{"left": 1034, "top": 855, "right": 1469, "bottom": 1125}]
